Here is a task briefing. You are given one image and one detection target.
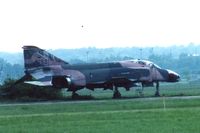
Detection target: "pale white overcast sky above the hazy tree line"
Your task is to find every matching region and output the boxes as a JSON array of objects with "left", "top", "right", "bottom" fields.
[{"left": 0, "top": 0, "right": 200, "bottom": 52}]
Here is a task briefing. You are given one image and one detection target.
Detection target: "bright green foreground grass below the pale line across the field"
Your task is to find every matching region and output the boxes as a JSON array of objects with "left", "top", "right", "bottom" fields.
[{"left": 0, "top": 108, "right": 200, "bottom": 133}]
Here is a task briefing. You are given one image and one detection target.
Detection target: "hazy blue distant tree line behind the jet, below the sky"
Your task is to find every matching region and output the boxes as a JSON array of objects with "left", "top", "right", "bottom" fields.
[{"left": 0, "top": 44, "right": 200, "bottom": 84}]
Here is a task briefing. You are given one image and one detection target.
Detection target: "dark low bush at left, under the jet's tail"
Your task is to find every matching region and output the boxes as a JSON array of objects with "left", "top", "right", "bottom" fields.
[{"left": 0, "top": 79, "right": 61, "bottom": 101}]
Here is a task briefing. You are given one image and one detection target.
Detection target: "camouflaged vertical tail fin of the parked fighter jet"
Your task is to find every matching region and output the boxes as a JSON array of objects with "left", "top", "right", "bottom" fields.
[{"left": 23, "top": 46, "right": 69, "bottom": 70}]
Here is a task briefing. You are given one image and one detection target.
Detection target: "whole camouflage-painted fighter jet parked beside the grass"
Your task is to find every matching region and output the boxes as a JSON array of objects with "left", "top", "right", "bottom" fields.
[{"left": 21, "top": 46, "right": 180, "bottom": 98}]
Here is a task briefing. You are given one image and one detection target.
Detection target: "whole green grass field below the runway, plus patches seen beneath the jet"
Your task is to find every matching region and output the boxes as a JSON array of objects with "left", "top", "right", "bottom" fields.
[{"left": 0, "top": 84, "right": 200, "bottom": 133}]
